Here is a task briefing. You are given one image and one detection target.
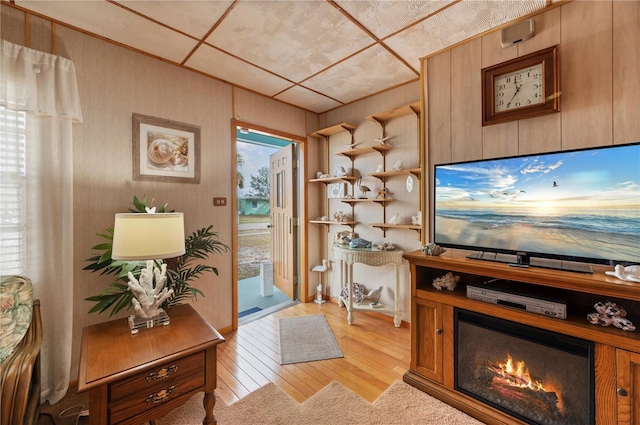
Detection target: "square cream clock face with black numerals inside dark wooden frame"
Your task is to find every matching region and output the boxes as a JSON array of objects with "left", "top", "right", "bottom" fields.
[{"left": 493, "top": 63, "right": 545, "bottom": 112}]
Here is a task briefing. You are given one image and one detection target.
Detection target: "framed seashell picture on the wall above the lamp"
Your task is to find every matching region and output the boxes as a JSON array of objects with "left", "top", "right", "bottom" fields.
[{"left": 133, "top": 114, "right": 200, "bottom": 183}]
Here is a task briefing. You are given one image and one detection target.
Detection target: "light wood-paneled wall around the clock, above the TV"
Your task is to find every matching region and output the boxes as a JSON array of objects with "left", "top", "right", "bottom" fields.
[{"left": 422, "top": 0, "right": 640, "bottom": 238}]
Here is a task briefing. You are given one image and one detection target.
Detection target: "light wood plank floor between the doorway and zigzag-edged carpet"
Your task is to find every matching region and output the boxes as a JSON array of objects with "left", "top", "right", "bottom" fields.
[{"left": 216, "top": 302, "right": 411, "bottom": 404}]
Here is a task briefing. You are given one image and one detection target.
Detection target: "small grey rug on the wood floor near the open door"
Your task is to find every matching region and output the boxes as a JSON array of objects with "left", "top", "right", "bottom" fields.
[{"left": 278, "top": 314, "right": 343, "bottom": 364}]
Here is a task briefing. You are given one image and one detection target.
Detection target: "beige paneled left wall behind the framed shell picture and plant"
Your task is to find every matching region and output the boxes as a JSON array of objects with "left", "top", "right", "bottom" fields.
[{"left": 0, "top": 2, "right": 318, "bottom": 376}]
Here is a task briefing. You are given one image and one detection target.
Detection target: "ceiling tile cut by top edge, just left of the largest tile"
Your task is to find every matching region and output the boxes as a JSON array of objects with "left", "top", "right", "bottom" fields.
[{"left": 112, "top": 0, "right": 233, "bottom": 40}]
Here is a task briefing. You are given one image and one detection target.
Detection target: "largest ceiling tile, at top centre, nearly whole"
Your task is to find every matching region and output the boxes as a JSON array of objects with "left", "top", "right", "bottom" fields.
[{"left": 206, "top": 0, "right": 373, "bottom": 82}]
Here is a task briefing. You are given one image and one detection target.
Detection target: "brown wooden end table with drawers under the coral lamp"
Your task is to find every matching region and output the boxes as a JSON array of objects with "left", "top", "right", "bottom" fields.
[{"left": 78, "top": 304, "right": 224, "bottom": 425}]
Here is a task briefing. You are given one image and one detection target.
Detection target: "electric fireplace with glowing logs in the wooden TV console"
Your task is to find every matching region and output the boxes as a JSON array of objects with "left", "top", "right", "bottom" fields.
[{"left": 454, "top": 309, "right": 595, "bottom": 425}]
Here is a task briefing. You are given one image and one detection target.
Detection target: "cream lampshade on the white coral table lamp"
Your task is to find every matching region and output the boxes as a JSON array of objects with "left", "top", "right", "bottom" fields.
[{"left": 111, "top": 213, "right": 185, "bottom": 261}]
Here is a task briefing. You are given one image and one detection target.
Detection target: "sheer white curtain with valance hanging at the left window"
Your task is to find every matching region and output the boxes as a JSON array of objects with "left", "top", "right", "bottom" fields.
[{"left": 0, "top": 40, "right": 82, "bottom": 403}]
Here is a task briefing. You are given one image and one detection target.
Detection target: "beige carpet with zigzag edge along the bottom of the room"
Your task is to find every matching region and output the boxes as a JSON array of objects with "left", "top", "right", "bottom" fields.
[{"left": 157, "top": 381, "right": 482, "bottom": 425}]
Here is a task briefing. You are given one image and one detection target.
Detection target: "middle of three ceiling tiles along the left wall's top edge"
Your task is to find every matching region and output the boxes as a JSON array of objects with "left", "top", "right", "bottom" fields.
[{"left": 185, "top": 45, "right": 291, "bottom": 96}]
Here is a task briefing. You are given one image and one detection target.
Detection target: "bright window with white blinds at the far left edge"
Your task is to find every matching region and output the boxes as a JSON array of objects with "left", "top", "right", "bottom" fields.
[{"left": 0, "top": 107, "right": 27, "bottom": 275}]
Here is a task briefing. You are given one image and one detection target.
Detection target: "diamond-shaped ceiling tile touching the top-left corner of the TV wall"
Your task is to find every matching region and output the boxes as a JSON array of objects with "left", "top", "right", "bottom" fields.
[{"left": 302, "top": 45, "right": 419, "bottom": 103}]
